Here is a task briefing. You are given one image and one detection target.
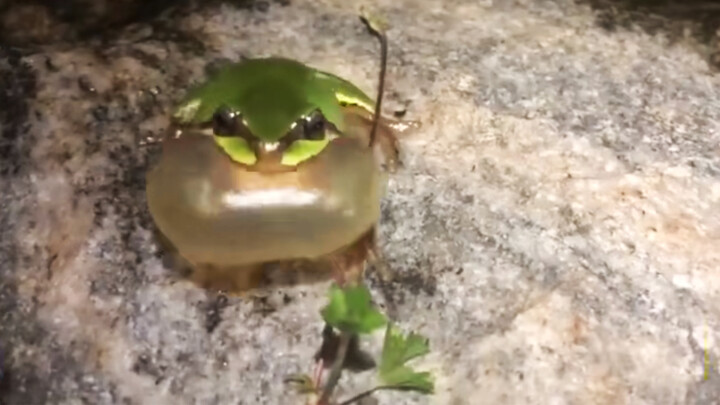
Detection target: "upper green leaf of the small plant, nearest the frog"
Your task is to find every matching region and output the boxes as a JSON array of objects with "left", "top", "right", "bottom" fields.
[{"left": 322, "top": 285, "right": 387, "bottom": 334}]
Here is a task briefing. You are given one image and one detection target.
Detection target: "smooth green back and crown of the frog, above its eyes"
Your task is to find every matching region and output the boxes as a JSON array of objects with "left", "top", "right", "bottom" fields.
[{"left": 175, "top": 58, "right": 374, "bottom": 141}]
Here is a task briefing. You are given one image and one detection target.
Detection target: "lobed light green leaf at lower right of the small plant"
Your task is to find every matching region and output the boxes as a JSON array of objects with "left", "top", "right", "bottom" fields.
[{"left": 379, "top": 324, "right": 435, "bottom": 394}]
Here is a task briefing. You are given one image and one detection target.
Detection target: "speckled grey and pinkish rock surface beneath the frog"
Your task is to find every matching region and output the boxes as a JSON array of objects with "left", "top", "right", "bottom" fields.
[{"left": 0, "top": 0, "right": 720, "bottom": 405}]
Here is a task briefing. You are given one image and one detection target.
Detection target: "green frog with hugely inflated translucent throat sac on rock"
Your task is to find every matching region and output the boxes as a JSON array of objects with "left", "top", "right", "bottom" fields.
[{"left": 146, "top": 18, "right": 413, "bottom": 292}]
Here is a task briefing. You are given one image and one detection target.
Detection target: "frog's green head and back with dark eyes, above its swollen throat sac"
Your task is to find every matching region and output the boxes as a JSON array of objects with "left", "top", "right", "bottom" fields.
[{"left": 174, "top": 58, "right": 374, "bottom": 167}]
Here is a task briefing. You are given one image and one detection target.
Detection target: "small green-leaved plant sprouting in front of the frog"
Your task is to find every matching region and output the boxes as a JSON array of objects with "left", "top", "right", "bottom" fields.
[{"left": 288, "top": 285, "right": 434, "bottom": 405}]
